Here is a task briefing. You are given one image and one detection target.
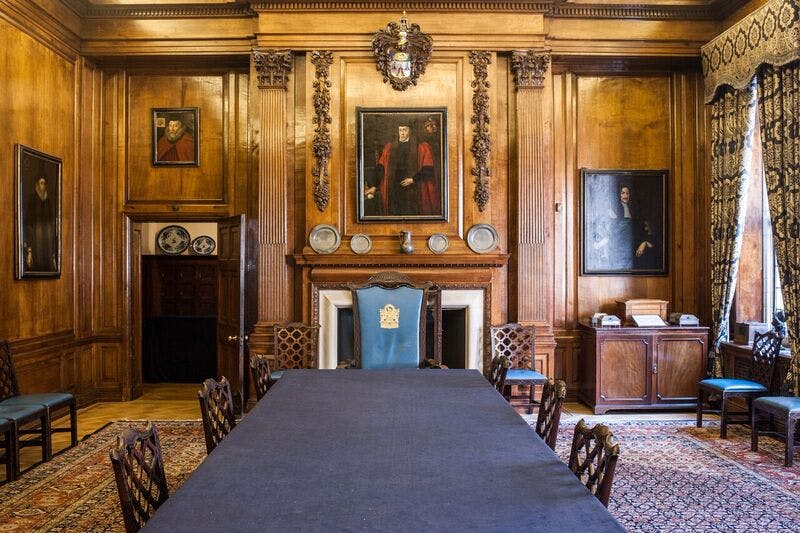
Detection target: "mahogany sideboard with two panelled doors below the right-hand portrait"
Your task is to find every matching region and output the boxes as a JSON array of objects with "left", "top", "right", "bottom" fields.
[{"left": 578, "top": 321, "right": 708, "bottom": 414}]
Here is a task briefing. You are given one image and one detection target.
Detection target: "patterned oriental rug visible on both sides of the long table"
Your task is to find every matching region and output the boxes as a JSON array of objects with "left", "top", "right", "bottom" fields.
[{"left": 0, "top": 421, "right": 800, "bottom": 532}]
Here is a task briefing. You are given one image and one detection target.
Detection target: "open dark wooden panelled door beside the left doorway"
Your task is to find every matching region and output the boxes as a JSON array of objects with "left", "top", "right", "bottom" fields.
[{"left": 217, "top": 214, "right": 248, "bottom": 413}]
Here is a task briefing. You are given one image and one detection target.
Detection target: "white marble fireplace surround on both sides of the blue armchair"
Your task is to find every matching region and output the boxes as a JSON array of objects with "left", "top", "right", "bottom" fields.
[{"left": 318, "top": 289, "right": 483, "bottom": 372}]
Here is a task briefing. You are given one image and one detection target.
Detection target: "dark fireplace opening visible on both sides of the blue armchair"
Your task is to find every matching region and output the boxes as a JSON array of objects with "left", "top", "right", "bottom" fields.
[{"left": 336, "top": 307, "right": 467, "bottom": 368}]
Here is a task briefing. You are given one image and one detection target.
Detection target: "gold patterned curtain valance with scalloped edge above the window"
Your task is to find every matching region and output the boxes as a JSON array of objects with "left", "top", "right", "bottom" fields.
[{"left": 701, "top": 0, "right": 800, "bottom": 103}]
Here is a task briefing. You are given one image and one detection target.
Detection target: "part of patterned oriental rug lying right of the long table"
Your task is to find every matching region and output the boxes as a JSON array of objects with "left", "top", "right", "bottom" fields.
[{"left": 556, "top": 418, "right": 800, "bottom": 532}]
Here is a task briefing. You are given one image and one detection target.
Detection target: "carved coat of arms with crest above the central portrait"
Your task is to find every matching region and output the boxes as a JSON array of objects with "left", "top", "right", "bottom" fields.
[{"left": 372, "top": 11, "right": 433, "bottom": 91}]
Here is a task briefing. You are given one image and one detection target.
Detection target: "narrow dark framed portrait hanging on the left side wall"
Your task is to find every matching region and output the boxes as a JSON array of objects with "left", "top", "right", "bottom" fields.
[{"left": 14, "top": 144, "right": 62, "bottom": 279}]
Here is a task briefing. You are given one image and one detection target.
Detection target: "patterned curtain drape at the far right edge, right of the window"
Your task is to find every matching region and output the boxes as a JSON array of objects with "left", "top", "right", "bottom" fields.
[{"left": 757, "top": 61, "right": 800, "bottom": 396}]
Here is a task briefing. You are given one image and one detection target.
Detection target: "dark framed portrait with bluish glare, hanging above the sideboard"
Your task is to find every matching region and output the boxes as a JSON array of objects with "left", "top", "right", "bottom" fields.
[{"left": 580, "top": 169, "right": 669, "bottom": 276}]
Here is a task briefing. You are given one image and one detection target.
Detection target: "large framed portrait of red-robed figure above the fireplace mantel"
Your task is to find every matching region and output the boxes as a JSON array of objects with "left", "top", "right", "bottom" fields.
[{"left": 356, "top": 107, "right": 448, "bottom": 222}]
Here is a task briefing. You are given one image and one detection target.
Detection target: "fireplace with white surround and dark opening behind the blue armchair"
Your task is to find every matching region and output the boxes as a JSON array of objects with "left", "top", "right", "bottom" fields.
[{"left": 316, "top": 289, "right": 484, "bottom": 371}]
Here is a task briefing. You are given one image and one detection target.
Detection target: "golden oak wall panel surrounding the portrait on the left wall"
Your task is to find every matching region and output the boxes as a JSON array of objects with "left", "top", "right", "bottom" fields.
[{"left": 0, "top": 19, "right": 77, "bottom": 340}]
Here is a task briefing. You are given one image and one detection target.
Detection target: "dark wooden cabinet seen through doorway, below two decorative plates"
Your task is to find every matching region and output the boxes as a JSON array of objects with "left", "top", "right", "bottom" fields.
[{"left": 142, "top": 256, "right": 217, "bottom": 383}]
